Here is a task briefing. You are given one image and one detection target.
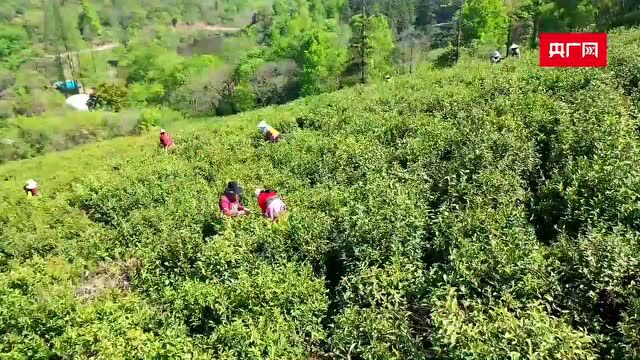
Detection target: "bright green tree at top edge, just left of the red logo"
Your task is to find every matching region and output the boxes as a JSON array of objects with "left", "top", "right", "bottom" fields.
[{"left": 460, "top": 0, "right": 507, "bottom": 44}]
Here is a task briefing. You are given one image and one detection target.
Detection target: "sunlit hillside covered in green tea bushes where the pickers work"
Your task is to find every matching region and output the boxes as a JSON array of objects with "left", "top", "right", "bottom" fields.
[{"left": 0, "top": 31, "right": 640, "bottom": 360}]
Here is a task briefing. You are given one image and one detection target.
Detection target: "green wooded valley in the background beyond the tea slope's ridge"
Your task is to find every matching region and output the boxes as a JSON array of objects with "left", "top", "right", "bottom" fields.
[{"left": 0, "top": 0, "right": 640, "bottom": 131}]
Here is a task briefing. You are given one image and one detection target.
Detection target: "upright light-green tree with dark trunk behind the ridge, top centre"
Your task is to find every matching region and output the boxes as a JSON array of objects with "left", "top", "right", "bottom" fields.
[{"left": 350, "top": 14, "right": 394, "bottom": 83}]
